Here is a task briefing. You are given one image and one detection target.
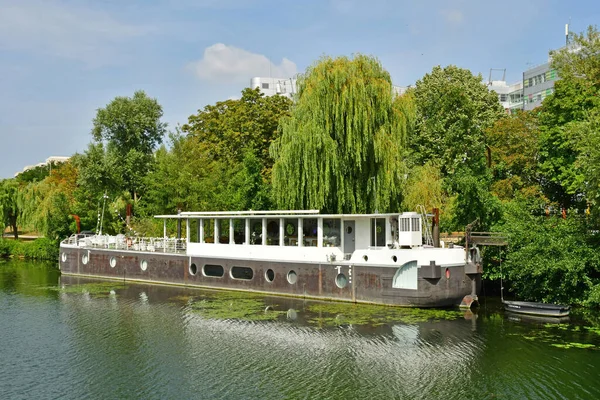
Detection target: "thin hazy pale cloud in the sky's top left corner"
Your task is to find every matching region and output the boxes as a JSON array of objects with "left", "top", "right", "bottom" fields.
[{"left": 0, "top": 0, "right": 152, "bottom": 66}]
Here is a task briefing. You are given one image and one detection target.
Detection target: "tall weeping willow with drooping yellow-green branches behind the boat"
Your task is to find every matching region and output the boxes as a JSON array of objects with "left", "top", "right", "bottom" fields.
[{"left": 271, "top": 55, "right": 413, "bottom": 213}]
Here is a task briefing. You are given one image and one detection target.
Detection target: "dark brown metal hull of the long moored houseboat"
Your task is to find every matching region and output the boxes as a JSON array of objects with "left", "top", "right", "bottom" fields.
[{"left": 59, "top": 246, "right": 481, "bottom": 307}]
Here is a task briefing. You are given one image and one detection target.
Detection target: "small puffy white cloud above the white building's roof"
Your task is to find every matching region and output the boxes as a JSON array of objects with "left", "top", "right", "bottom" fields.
[{"left": 189, "top": 43, "right": 297, "bottom": 82}]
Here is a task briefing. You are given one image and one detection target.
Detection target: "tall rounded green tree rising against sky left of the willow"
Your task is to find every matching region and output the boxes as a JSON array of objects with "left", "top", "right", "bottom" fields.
[{"left": 89, "top": 91, "right": 166, "bottom": 202}]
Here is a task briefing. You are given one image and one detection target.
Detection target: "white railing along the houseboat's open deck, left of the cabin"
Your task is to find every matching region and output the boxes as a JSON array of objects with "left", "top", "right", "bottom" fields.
[{"left": 63, "top": 235, "right": 186, "bottom": 253}]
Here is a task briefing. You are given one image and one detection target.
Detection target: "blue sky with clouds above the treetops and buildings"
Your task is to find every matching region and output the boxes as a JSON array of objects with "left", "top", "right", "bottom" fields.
[{"left": 0, "top": 0, "right": 600, "bottom": 178}]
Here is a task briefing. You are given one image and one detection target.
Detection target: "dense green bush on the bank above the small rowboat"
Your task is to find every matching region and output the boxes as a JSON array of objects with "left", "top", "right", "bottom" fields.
[{"left": 496, "top": 201, "right": 600, "bottom": 304}]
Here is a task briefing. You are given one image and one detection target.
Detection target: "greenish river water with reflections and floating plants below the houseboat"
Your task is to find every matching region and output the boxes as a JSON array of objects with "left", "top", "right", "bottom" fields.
[{"left": 0, "top": 261, "right": 600, "bottom": 399}]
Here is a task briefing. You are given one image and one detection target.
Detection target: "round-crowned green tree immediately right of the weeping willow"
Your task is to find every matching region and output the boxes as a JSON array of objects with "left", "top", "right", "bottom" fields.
[{"left": 410, "top": 65, "right": 504, "bottom": 176}]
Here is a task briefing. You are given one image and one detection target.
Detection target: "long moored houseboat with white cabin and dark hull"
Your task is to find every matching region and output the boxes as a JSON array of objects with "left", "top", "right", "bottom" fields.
[{"left": 59, "top": 210, "right": 482, "bottom": 307}]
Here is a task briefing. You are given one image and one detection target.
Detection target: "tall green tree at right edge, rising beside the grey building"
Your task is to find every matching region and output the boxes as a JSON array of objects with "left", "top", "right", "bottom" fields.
[{"left": 539, "top": 27, "right": 600, "bottom": 208}]
